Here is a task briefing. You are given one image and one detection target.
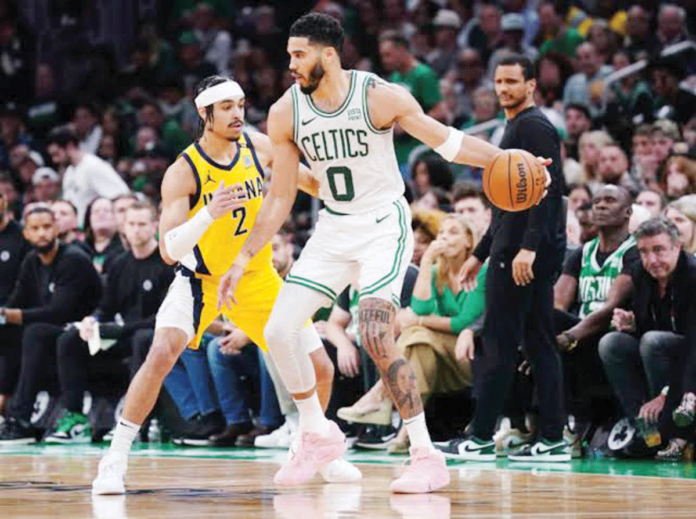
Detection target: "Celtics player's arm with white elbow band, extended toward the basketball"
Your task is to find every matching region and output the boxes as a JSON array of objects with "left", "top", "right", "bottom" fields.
[{"left": 368, "top": 79, "right": 502, "bottom": 168}]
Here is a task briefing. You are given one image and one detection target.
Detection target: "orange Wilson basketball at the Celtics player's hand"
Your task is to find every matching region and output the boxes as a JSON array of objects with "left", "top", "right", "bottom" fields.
[{"left": 483, "top": 149, "right": 546, "bottom": 212}]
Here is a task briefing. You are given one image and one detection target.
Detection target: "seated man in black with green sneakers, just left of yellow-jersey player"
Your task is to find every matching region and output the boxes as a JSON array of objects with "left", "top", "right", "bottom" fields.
[{"left": 45, "top": 202, "right": 174, "bottom": 444}]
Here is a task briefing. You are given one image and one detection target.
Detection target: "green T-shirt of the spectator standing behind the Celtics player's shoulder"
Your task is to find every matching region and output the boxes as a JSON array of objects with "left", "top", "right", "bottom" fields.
[{"left": 389, "top": 63, "right": 442, "bottom": 166}]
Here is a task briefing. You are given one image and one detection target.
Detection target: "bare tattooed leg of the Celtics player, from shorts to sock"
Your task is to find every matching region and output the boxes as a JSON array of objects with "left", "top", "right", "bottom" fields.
[{"left": 358, "top": 298, "right": 423, "bottom": 418}]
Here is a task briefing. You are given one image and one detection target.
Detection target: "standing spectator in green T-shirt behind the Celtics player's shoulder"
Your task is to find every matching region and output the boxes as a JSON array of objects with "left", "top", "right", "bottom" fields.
[{"left": 379, "top": 31, "right": 445, "bottom": 176}]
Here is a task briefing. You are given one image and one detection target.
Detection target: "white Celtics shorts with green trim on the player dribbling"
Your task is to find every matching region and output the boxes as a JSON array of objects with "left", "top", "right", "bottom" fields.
[{"left": 285, "top": 197, "right": 413, "bottom": 308}]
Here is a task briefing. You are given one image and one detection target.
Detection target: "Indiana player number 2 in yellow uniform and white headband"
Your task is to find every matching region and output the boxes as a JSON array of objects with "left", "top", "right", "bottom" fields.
[{"left": 92, "top": 76, "right": 360, "bottom": 494}]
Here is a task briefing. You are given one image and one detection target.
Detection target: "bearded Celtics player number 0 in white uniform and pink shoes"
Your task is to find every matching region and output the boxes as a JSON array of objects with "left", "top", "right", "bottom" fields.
[{"left": 219, "top": 13, "right": 548, "bottom": 493}]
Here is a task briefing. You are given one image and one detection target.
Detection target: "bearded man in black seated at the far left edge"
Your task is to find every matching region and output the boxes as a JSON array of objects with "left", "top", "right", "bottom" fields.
[{"left": 0, "top": 206, "right": 102, "bottom": 446}]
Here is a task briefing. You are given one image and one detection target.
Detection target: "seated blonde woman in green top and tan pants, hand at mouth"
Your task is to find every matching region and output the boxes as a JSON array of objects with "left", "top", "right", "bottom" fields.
[{"left": 338, "top": 214, "right": 487, "bottom": 453}]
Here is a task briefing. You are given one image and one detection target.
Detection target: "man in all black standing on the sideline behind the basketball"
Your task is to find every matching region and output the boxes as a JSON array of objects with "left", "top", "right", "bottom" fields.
[{"left": 445, "top": 55, "right": 570, "bottom": 462}]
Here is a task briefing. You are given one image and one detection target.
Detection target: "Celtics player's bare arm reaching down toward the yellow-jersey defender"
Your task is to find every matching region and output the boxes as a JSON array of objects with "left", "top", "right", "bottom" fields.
[{"left": 218, "top": 91, "right": 300, "bottom": 308}]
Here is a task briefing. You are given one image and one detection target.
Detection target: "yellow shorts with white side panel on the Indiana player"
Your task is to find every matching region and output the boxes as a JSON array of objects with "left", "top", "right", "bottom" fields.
[{"left": 155, "top": 265, "right": 283, "bottom": 351}]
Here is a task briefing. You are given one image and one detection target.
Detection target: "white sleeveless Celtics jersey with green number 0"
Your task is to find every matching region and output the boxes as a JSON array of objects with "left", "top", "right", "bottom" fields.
[{"left": 290, "top": 70, "right": 404, "bottom": 214}]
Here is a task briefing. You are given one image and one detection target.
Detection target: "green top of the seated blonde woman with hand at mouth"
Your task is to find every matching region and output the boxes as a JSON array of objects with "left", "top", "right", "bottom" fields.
[{"left": 411, "top": 263, "right": 488, "bottom": 335}]
